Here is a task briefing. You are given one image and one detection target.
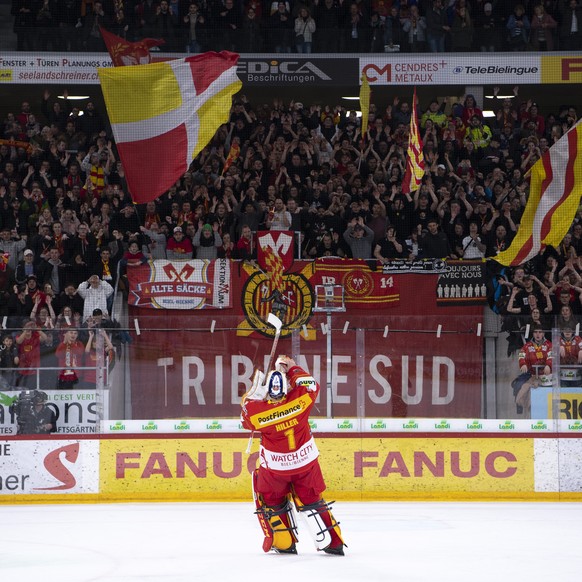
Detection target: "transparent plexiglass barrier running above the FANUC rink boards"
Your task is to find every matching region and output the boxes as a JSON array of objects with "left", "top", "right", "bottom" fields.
[{"left": 0, "top": 308, "right": 582, "bottom": 434}]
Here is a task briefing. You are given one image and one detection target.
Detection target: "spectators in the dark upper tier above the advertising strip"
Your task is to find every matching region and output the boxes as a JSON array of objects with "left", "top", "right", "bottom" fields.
[{"left": 12, "top": 0, "right": 582, "bottom": 53}]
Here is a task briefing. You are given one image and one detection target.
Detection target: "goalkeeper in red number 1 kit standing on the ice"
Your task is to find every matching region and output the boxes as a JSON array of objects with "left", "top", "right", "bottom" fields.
[{"left": 241, "top": 356, "right": 345, "bottom": 556}]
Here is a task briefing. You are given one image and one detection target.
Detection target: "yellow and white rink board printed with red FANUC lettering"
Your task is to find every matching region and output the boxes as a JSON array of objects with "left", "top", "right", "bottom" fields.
[{"left": 0, "top": 432, "right": 582, "bottom": 503}]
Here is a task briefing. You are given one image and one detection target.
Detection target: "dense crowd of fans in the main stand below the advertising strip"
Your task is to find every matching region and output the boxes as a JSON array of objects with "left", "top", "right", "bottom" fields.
[{"left": 0, "top": 74, "right": 582, "bottom": 406}]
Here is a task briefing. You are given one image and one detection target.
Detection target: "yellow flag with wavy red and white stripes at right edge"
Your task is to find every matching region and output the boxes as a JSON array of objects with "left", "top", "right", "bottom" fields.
[{"left": 494, "top": 121, "right": 582, "bottom": 266}]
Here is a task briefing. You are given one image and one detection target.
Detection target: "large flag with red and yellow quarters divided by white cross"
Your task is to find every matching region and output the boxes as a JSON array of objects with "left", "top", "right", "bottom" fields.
[{"left": 98, "top": 51, "right": 242, "bottom": 203}]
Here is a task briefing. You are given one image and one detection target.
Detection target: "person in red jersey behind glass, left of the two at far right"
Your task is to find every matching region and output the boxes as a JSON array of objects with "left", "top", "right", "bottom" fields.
[{"left": 512, "top": 326, "right": 552, "bottom": 413}]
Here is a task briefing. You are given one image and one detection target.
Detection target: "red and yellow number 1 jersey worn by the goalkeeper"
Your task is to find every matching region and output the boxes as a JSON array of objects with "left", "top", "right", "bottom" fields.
[{"left": 241, "top": 366, "right": 319, "bottom": 474}]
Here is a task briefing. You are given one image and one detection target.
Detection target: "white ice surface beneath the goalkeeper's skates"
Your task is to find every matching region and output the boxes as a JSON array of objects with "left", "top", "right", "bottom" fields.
[{"left": 0, "top": 502, "right": 582, "bottom": 582}]
